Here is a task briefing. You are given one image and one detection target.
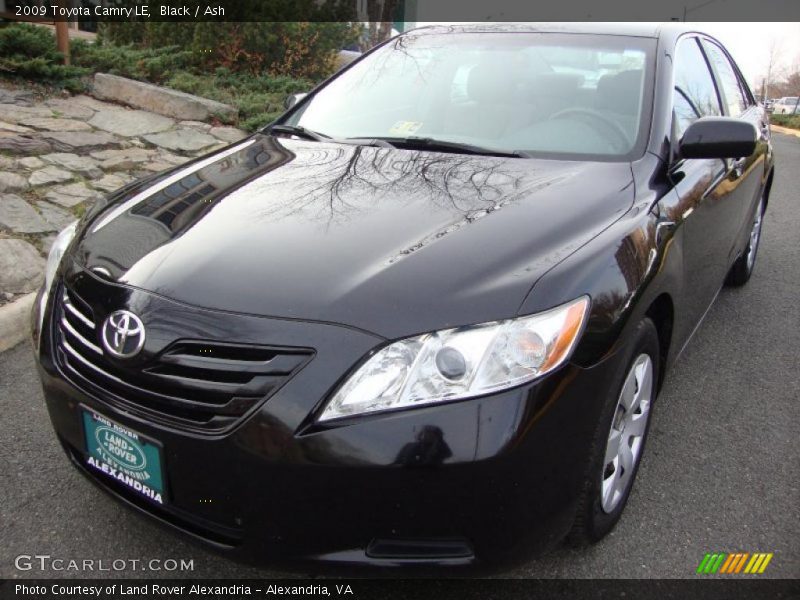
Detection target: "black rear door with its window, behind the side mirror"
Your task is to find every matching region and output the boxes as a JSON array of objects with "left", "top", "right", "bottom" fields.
[{"left": 701, "top": 39, "right": 769, "bottom": 264}]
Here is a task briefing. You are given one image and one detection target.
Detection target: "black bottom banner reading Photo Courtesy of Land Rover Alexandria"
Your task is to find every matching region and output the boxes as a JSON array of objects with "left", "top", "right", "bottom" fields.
[{"left": 0, "top": 579, "right": 800, "bottom": 600}]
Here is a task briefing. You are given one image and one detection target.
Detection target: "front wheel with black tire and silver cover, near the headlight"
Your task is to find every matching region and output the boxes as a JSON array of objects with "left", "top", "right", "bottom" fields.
[{"left": 567, "top": 318, "right": 659, "bottom": 546}]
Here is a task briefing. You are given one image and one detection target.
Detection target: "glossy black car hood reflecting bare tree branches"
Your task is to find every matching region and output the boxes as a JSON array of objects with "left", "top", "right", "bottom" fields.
[{"left": 73, "top": 134, "right": 633, "bottom": 338}]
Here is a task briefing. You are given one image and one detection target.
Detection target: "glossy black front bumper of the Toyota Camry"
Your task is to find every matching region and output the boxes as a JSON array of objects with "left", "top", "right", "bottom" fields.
[{"left": 34, "top": 270, "right": 616, "bottom": 566}]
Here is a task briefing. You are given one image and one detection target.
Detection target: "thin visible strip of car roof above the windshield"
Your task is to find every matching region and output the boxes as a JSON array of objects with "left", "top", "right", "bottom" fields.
[{"left": 403, "top": 22, "right": 696, "bottom": 38}]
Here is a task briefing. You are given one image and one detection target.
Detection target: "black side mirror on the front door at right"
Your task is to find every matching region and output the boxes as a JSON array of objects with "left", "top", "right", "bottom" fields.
[{"left": 680, "top": 117, "right": 758, "bottom": 158}]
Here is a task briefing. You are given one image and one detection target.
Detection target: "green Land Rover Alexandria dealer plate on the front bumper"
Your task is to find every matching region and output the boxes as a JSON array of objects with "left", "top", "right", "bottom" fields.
[{"left": 81, "top": 408, "right": 166, "bottom": 504}]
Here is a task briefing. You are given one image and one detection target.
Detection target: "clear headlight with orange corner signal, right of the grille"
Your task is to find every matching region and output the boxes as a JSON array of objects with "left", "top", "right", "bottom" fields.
[{"left": 319, "top": 296, "right": 589, "bottom": 421}]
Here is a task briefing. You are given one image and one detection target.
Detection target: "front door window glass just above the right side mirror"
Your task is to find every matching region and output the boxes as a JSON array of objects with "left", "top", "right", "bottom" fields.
[{"left": 673, "top": 38, "right": 722, "bottom": 139}]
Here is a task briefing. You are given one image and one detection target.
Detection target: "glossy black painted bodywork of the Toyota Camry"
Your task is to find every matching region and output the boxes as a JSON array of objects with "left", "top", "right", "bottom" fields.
[{"left": 32, "top": 22, "right": 772, "bottom": 566}]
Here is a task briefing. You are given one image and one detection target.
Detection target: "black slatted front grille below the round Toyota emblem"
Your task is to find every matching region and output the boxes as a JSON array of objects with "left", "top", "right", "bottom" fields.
[{"left": 54, "top": 286, "right": 312, "bottom": 433}]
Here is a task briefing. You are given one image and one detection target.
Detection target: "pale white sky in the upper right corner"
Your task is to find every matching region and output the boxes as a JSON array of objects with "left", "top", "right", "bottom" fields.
[{"left": 417, "top": 22, "right": 800, "bottom": 90}]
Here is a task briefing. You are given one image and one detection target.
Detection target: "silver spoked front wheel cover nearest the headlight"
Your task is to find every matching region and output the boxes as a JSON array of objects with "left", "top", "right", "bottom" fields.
[{"left": 601, "top": 354, "right": 653, "bottom": 513}]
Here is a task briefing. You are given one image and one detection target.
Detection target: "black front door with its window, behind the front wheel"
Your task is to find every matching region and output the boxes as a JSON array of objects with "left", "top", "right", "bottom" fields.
[{"left": 670, "top": 37, "right": 736, "bottom": 336}]
